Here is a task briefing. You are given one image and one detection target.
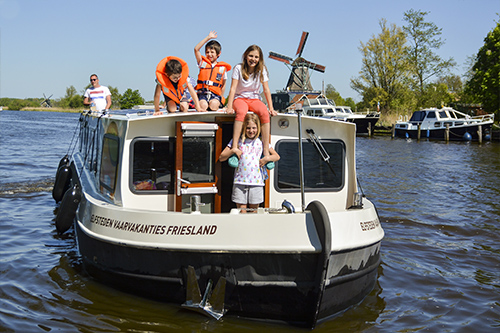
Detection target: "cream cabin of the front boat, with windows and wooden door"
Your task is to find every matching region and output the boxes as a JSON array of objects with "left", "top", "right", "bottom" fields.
[{"left": 80, "top": 112, "right": 356, "bottom": 213}]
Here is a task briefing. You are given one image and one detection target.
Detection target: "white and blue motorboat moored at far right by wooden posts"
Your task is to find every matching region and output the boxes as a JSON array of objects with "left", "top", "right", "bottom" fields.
[{"left": 394, "top": 107, "right": 495, "bottom": 141}]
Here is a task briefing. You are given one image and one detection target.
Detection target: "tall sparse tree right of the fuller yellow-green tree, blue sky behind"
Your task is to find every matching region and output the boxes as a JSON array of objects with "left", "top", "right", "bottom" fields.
[{"left": 403, "top": 9, "right": 455, "bottom": 106}]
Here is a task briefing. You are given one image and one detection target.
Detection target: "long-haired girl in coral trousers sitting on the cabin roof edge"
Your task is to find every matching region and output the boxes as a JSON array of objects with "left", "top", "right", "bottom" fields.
[{"left": 226, "top": 45, "right": 277, "bottom": 158}]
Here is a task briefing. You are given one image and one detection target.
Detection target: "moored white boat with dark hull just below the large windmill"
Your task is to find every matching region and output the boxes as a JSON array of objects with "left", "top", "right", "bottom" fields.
[{"left": 291, "top": 94, "right": 380, "bottom": 135}]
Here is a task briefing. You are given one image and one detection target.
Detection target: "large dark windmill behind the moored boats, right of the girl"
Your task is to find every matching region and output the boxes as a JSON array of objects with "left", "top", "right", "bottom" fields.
[{"left": 269, "top": 31, "right": 325, "bottom": 92}]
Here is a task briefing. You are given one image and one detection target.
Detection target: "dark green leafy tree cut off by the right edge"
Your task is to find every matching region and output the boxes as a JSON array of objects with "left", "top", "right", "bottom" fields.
[{"left": 465, "top": 20, "right": 500, "bottom": 117}]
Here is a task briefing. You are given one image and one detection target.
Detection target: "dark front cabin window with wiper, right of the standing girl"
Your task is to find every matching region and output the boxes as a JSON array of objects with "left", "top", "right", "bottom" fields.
[{"left": 275, "top": 140, "right": 345, "bottom": 192}]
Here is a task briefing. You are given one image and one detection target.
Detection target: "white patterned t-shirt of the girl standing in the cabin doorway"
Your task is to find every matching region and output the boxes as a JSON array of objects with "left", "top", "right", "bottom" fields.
[{"left": 228, "top": 138, "right": 265, "bottom": 186}]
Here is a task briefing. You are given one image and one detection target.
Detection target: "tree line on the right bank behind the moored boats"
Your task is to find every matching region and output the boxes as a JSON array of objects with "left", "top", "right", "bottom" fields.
[{"left": 348, "top": 9, "right": 500, "bottom": 117}]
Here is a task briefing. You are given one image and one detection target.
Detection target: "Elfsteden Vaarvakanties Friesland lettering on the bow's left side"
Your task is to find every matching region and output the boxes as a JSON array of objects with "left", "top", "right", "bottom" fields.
[{"left": 90, "top": 215, "right": 217, "bottom": 236}]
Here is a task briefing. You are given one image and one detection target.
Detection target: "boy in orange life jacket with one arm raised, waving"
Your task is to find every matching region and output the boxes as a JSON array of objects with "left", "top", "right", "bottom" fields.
[{"left": 194, "top": 31, "right": 231, "bottom": 111}]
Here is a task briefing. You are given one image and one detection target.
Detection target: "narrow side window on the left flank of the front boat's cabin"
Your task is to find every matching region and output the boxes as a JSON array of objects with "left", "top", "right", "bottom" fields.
[{"left": 99, "top": 134, "right": 120, "bottom": 194}]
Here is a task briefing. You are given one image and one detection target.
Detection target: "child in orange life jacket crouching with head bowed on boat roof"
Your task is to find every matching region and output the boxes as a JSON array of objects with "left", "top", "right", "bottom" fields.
[{"left": 154, "top": 56, "right": 202, "bottom": 115}]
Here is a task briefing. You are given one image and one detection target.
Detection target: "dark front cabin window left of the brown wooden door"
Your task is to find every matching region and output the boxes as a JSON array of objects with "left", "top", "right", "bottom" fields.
[{"left": 130, "top": 138, "right": 175, "bottom": 194}]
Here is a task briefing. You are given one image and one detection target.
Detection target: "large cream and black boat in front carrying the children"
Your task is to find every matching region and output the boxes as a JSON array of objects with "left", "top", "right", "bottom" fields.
[{"left": 53, "top": 110, "right": 384, "bottom": 328}]
